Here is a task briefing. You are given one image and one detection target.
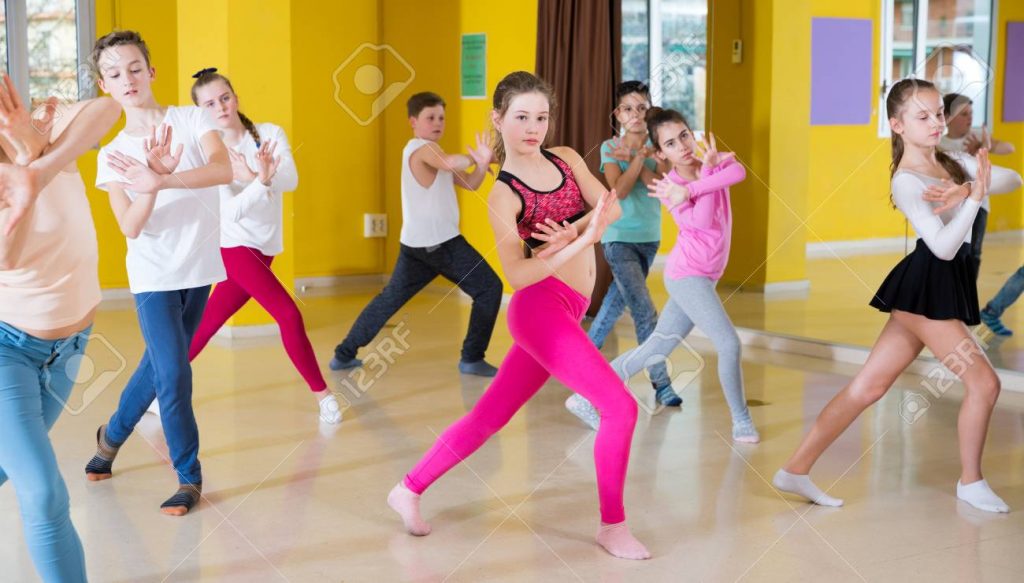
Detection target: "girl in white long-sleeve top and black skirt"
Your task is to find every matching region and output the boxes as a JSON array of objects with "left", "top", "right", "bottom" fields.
[{"left": 773, "top": 79, "right": 1021, "bottom": 512}]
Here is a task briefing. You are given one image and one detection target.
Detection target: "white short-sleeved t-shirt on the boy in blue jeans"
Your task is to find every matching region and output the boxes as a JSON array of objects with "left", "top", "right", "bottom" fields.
[{"left": 96, "top": 106, "right": 226, "bottom": 294}]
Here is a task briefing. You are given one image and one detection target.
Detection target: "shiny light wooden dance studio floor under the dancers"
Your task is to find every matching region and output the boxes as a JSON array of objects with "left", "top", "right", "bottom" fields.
[{"left": 0, "top": 278, "right": 1024, "bottom": 583}]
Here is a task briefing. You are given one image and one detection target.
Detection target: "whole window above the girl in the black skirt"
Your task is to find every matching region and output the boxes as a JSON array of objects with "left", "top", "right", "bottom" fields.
[{"left": 879, "top": 0, "right": 993, "bottom": 136}]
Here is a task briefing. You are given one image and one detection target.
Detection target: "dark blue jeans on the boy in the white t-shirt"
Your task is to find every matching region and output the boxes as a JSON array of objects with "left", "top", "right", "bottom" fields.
[{"left": 106, "top": 286, "right": 210, "bottom": 484}]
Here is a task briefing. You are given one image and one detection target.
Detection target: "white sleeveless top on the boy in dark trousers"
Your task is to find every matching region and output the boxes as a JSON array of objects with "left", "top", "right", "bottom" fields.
[{"left": 398, "top": 137, "right": 459, "bottom": 247}]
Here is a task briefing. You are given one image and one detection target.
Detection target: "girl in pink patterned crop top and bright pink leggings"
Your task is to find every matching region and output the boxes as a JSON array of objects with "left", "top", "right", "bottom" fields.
[{"left": 388, "top": 72, "right": 650, "bottom": 559}]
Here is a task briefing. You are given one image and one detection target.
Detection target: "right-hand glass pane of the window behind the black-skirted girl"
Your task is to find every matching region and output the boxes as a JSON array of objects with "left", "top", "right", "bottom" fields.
[{"left": 919, "top": 0, "right": 993, "bottom": 126}]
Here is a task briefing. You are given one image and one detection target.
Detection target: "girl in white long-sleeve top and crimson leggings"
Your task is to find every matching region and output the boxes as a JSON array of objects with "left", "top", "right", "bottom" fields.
[{"left": 188, "top": 69, "right": 341, "bottom": 423}]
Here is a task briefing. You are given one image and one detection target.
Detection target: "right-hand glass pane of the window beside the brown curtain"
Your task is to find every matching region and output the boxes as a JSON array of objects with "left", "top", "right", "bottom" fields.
[{"left": 651, "top": 0, "right": 708, "bottom": 130}]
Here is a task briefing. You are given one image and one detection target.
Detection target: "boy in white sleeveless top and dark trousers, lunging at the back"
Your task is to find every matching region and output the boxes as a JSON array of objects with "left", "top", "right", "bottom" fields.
[{"left": 331, "top": 92, "right": 502, "bottom": 377}]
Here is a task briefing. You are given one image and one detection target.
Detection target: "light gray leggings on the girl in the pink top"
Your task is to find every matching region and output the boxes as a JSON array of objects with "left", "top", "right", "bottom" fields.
[{"left": 611, "top": 277, "right": 751, "bottom": 423}]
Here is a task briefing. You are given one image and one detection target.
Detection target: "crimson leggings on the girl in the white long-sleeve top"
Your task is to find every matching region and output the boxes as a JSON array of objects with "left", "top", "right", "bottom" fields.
[{"left": 188, "top": 247, "right": 327, "bottom": 391}]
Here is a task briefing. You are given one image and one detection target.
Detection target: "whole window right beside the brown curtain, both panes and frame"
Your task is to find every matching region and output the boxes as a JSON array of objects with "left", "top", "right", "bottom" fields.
[{"left": 623, "top": 0, "right": 708, "bottom": 130}]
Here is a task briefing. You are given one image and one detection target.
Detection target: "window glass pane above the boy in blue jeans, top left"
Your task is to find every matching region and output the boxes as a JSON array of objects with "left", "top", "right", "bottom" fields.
[{"left": 26, "top": 0, "right": 79, "bottom": 109}]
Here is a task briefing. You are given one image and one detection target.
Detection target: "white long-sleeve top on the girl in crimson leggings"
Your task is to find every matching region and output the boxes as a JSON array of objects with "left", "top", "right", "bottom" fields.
[{"left": 219, "top": 124, "right": 299, "bottom": 255}]
